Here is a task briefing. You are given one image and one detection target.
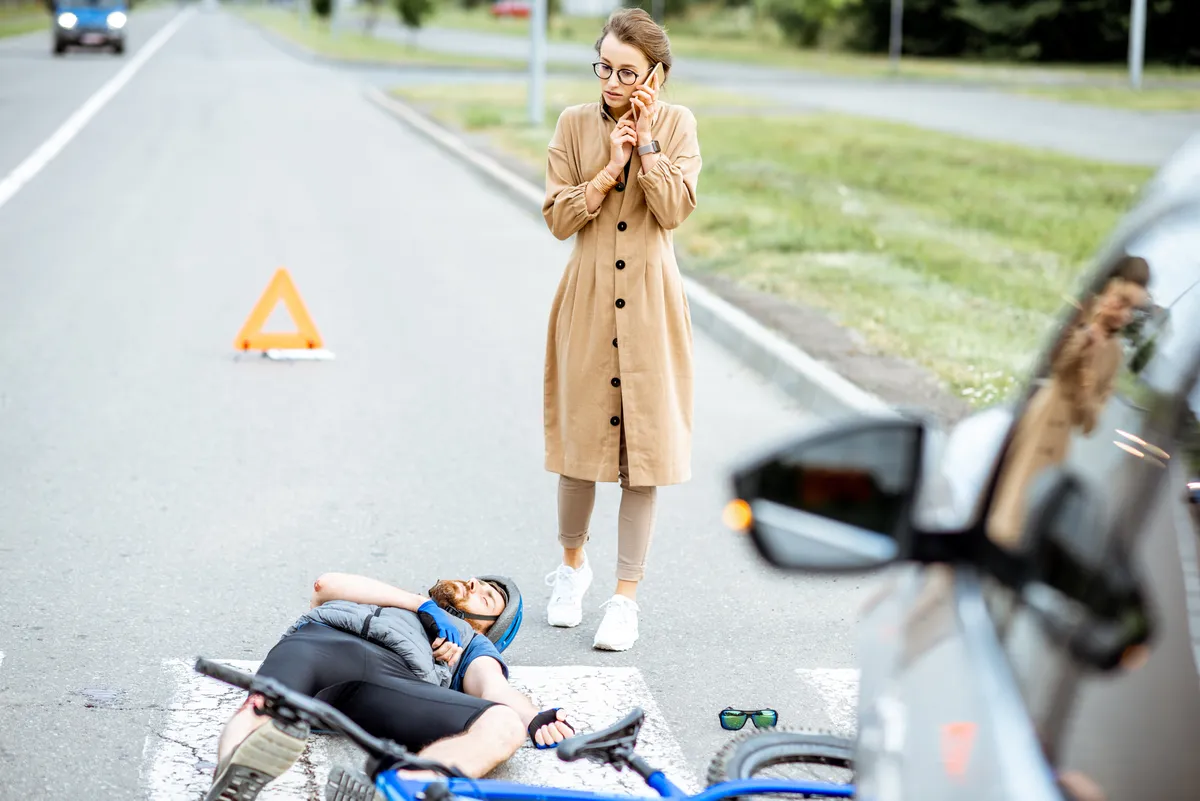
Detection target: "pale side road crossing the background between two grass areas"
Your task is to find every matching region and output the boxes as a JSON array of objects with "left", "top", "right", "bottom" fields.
[{"left": 378, "top": 20, "right": 1200, "bottom": 167}]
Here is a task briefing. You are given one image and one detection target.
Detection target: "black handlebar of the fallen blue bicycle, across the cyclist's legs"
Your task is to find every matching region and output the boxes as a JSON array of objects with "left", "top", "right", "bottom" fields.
[{"left": 196, "top": 657, "right": 464, "bottom": 777}]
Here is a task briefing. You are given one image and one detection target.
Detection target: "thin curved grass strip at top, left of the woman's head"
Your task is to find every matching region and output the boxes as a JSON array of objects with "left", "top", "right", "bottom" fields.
[{"left": 230, "top": 6, "right": 524, "bottom": 70}]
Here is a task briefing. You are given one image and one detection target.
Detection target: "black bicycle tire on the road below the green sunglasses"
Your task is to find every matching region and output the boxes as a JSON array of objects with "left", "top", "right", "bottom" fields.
[{"left": 707, "top": 727, "right": 854, "bottom": 801}]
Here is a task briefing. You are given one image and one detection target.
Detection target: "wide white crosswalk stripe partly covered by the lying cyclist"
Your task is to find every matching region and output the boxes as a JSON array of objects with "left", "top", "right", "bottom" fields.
[{"left": 142, "top": 660, "right": 701, "bottom": 801}]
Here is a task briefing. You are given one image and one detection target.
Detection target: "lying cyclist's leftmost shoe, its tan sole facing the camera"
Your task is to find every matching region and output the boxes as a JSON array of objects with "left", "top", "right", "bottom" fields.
[{"left": 204, "top": 721, "right": 308, "bottom": 801}]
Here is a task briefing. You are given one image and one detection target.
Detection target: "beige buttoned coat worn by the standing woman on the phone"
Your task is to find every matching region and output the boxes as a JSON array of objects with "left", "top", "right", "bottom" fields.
[{"left": 542, "top": 101, "right": 701, "bottom": 487}]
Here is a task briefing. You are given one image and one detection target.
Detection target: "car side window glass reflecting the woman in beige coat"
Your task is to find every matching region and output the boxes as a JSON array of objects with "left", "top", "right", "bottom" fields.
[{"left": 986, "top": 207, "right": 1200, "bottom": 549}]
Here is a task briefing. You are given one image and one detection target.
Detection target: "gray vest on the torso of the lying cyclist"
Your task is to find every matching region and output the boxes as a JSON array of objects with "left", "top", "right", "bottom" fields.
[{"left": 283, "top": 601, "right": 475, "bottom": 687}]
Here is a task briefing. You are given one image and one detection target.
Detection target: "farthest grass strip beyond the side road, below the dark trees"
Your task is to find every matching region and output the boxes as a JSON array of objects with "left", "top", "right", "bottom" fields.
[{"left": 430, "top": 6, "right": 1200, "bottom": 110}]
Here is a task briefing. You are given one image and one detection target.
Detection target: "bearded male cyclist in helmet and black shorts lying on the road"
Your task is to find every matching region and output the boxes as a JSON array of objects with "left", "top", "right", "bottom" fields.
[{"left": 205, "top": 573, "right": 575, "bottom": 801}]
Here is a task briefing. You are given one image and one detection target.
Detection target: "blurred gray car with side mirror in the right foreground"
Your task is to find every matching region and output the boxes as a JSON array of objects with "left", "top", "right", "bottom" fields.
[{"left": 734, "top": 135, "right": 1200, "bottom": 801}]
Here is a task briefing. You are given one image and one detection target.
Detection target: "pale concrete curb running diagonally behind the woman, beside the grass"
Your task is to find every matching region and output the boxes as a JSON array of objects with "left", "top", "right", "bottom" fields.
[{"left": 366, "top": 88, "right": 892, "bottom": 418}]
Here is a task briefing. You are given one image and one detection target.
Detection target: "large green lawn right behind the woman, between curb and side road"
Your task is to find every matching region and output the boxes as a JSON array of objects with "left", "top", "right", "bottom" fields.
[{"left": 395, "top": 80, "right": 1151, "bottom": 404}]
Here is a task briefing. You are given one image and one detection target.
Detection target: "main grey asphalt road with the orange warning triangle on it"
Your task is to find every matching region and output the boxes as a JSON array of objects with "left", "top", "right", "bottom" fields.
[{"left": 0, "top": 7, "right": 869, "bottom": 799}]
